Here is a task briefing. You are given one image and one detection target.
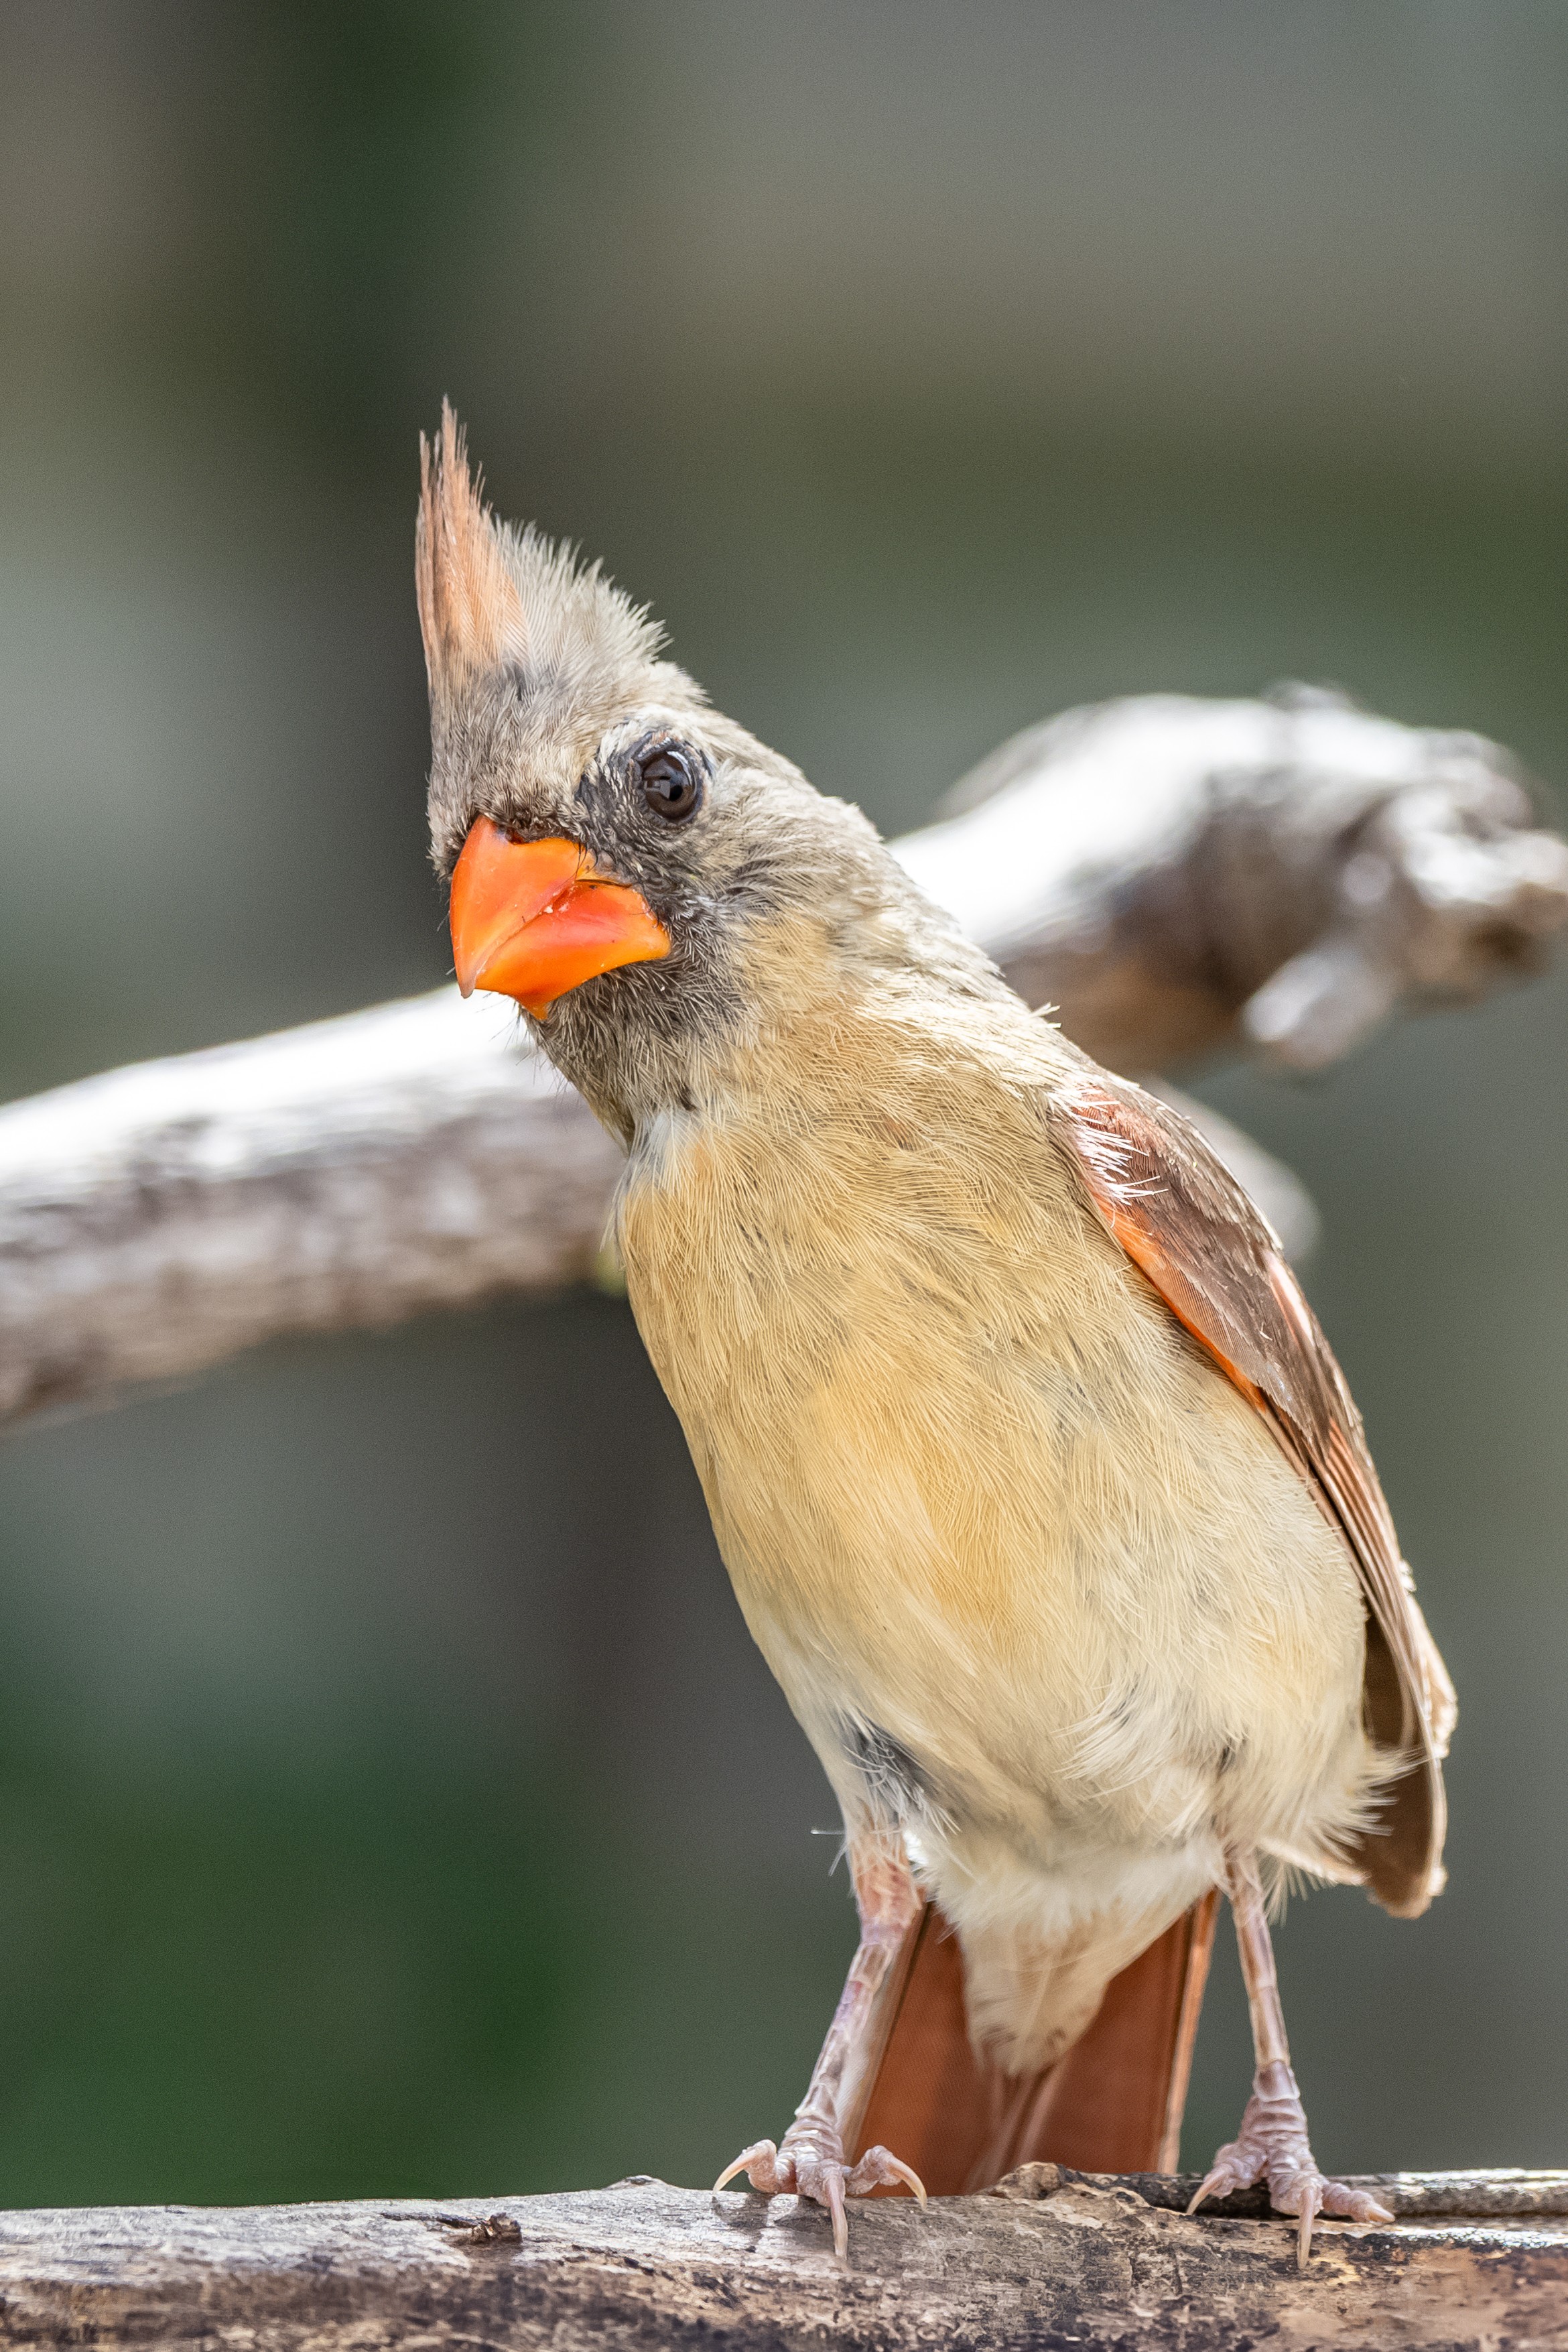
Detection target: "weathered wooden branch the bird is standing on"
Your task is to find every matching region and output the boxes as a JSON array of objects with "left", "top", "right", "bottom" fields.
[{"left": 0, "top": 2166, "right": 1568, "bottom": 2352}]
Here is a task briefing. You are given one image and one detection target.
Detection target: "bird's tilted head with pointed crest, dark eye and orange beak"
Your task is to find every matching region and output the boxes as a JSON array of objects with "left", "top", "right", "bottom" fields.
[{"left": 416, "top": 407, "right": 992, "bottom": 1133}]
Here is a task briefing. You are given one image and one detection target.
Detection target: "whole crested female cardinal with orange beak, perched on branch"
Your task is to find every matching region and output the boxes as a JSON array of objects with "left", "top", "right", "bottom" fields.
[{"left": 416, "top": 402, "right": 1455, "bottom": 2263}]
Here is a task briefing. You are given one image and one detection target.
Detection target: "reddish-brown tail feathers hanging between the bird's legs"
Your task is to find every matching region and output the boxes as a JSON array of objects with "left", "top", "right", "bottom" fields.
[{"left": 846, "top": 1894, "right": 1218, "bottom": 2196}]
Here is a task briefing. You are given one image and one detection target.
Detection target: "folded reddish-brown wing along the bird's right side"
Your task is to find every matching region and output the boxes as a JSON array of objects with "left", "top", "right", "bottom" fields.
[{"left": 1051, "top": 1070, "right": 1455, "bottom": 1917}]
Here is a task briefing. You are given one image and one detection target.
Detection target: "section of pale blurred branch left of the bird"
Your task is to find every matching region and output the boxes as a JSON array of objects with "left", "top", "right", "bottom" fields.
[{"left": 0, "top": 988, "right": 620, "bottom": 1418}]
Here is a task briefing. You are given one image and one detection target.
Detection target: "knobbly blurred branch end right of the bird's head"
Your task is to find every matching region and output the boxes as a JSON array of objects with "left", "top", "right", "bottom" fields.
[{"left": 896, "top": 687, "right": 1568, "bottom": 1072}]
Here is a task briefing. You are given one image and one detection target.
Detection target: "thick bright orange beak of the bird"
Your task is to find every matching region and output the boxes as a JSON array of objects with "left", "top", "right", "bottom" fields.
[{"left": 449, "top": 816, "right": 670, "bottom": 1021}]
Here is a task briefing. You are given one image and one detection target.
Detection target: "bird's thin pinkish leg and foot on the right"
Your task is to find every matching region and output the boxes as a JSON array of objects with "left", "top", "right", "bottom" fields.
[{"left": 1187, "top": 1849, "right": 1394, "bottom": 2270}]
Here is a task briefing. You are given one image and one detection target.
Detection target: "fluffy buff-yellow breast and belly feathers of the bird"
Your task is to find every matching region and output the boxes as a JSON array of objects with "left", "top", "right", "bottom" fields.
[{"left": 620, "top": 999, "right": 1361, "bottom": 1872}]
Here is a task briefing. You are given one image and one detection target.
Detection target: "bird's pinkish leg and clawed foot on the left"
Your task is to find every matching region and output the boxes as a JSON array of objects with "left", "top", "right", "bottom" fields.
[{"left": 715, "top": 1835, "right": 926, "bottom": 2258}]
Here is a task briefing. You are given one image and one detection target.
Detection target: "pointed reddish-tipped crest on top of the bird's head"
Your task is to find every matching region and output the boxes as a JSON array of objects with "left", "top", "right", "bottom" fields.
[{"left": 413, "top": 400, "right": 663, "bottom": 701}]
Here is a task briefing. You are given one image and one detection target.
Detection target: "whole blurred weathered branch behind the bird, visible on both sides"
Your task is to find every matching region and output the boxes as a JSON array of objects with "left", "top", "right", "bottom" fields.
[{"left": 0, "top": 692, "right": 1568, "bottom": 1420}]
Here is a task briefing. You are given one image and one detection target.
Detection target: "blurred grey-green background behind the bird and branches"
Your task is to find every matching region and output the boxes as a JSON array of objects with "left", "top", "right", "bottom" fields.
[{"left": 0, "top": 0, "right": 1568, "bottom": 2204}]
